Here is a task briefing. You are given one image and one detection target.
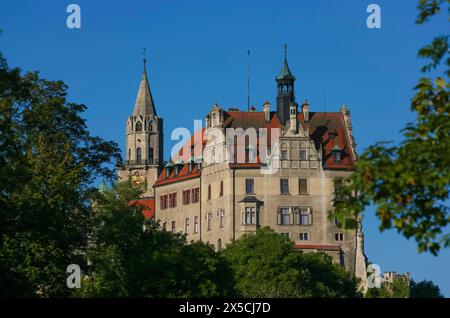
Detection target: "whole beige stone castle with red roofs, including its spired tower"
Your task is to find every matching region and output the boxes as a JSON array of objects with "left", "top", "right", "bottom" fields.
[{"left": 119, "top": 50, "right": 366, "bottom": 281}]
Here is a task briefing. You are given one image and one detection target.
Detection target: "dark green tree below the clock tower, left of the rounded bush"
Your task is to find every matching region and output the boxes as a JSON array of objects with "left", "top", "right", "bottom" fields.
[{"left": 78, "top": 181, "right": 234, "bottom": 298}]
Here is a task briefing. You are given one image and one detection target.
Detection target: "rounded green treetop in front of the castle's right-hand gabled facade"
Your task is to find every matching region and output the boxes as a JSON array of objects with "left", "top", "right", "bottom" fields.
[{"left": 223, "top": 227, "right": 360, "bottom": 297}]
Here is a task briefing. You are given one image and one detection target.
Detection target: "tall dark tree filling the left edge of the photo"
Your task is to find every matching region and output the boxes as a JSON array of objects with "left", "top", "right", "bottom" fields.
[{"left": 0, "top": 54, "right": 118, "bottom": 297}]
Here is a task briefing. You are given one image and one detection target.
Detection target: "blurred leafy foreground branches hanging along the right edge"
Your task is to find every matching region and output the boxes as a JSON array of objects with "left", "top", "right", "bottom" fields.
[{"left": 330, "top": 0, "right": 450, "bottom": 255}]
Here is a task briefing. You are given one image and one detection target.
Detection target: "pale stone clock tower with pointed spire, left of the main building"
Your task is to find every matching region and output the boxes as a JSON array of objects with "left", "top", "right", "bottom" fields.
[{"left": 118, "top": 57, "right": 163, "bottom": 198}]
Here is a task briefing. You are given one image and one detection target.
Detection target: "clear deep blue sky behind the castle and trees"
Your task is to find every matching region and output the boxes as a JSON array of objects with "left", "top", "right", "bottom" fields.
[{"left": 0, "top": 0, "right": 450, "bottom": 296}]
